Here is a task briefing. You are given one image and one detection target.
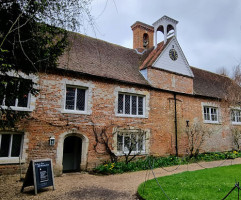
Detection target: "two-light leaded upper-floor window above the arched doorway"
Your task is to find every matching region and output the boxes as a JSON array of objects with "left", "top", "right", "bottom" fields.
[{"left": 65, "top": 86, "right": 86, "bottom": 111}]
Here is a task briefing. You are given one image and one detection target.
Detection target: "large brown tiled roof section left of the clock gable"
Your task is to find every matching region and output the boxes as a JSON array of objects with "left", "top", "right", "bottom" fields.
[{"left": 59, "top": 33, "right": 149, "bottom": 85}]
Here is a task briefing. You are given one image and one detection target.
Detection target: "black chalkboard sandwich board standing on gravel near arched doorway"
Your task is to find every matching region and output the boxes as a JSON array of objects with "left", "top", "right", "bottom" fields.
[{"left": 21, "top": 159, "right": 54, "bottom": 194}]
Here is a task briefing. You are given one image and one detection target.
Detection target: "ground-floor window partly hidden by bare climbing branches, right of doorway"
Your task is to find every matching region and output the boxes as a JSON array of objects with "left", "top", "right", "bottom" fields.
[{"left": 117, "top": 131, "right": 146, "bottom": 154}]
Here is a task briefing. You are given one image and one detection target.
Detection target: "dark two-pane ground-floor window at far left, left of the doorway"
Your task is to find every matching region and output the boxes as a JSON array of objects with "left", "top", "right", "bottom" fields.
[{"left": 0, "top": 134, "right": 23, "bottom": 158}]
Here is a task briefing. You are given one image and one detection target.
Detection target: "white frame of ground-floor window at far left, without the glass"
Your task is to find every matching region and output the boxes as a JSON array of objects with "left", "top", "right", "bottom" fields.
[{"left": 0, "top": 133, "right": 24, "bottom": 161}]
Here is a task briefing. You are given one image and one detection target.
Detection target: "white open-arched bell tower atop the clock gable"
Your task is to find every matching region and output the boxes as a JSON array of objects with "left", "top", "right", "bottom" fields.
[{"left": 152, "top": 15, "right": 178, "bottom": 48}]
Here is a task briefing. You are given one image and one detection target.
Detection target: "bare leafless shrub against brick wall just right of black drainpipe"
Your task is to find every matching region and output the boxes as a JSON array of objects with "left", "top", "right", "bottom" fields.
[{"left": 185, "top": 122, "right": 212, "bottom": 157}]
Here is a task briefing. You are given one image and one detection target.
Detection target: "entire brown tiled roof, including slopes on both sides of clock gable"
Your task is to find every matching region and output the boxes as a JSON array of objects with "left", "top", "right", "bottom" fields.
[{"left": 59, "top": 33, "right": 241, "bottom": 98}]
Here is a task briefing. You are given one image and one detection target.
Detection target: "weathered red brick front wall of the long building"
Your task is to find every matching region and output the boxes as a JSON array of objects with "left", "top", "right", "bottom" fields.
[{"left": 0, "top": 71, "right": 238, "bottom": 173}]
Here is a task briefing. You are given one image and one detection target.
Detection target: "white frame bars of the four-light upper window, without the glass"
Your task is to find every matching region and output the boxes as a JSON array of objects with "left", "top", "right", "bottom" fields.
[{"left": 116, "top": 92, "right": 146, "bottom": 117}]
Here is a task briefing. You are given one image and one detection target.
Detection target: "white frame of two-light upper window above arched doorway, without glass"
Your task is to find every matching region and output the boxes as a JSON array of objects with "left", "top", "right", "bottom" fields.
[{"left": 62, "top": 84, "right": 88, "bottom": 114}]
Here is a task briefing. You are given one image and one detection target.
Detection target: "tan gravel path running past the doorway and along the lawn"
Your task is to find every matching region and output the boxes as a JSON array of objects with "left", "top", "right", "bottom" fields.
[{"left": 0, "top": 158, "right": 241, "bottom": 200}]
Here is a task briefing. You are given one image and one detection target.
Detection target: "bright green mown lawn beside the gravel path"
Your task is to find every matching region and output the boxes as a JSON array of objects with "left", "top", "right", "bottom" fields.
[{"left": 138, "top": 165, "right": 241, "bottom": 200}]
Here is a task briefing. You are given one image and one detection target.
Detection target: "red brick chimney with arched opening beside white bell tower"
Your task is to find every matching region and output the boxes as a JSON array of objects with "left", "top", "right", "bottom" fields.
[{"left": 131, "top": 21, "right": 154, "bottom": 52}]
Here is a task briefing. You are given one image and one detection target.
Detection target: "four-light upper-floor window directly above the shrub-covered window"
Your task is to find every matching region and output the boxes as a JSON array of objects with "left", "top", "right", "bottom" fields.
[{"left": 118, "top": 93, "right": 144, "bottom": 116}]
